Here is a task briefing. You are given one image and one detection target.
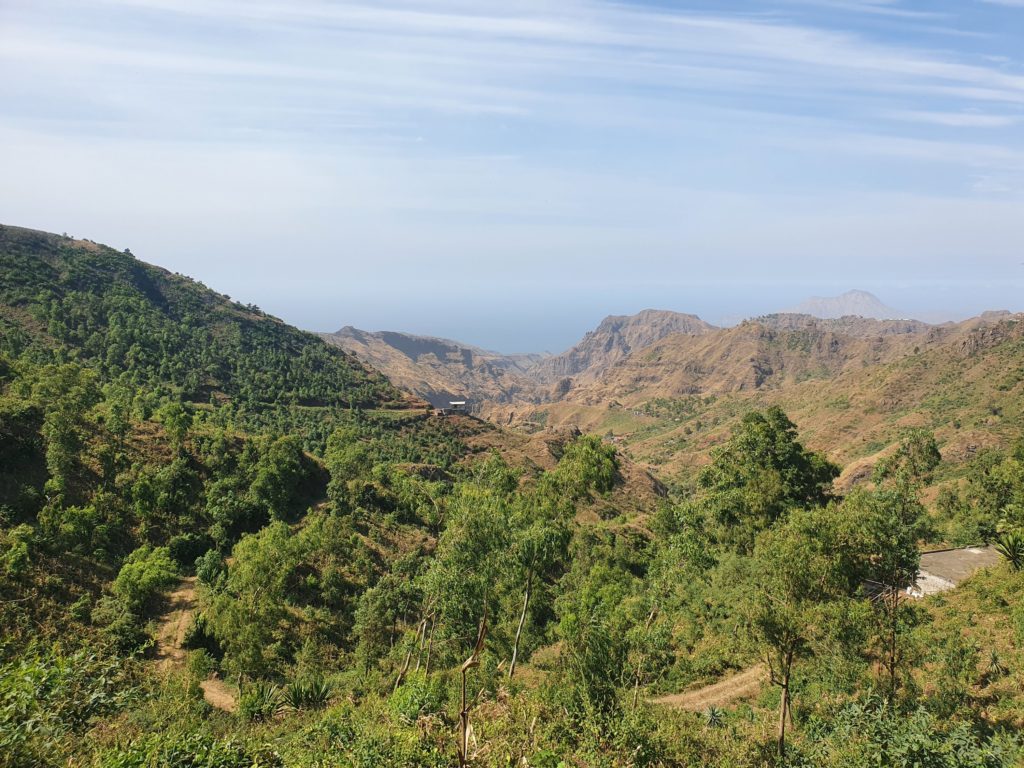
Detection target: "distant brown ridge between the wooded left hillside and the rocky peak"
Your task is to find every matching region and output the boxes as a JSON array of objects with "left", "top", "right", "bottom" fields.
[{"left": 322, "top": 326, "right": 545, "bottom": 408}]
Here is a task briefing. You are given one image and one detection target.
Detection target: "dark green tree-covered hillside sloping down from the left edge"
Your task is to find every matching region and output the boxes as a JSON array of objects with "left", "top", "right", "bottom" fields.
[{"left": 0, "top": 226, "right": 400, "bottom": 423}]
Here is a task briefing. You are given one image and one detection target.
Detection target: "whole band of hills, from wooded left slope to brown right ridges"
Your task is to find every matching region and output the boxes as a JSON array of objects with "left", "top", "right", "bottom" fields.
[{"left": 0, "top": 221, "right": 1024, "bottom": 493}]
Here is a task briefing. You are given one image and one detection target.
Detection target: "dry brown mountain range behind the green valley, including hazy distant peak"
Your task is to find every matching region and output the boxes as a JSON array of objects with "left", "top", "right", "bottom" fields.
[{"left": 326, "top": 292, "right": 1024, "bottom": 489}]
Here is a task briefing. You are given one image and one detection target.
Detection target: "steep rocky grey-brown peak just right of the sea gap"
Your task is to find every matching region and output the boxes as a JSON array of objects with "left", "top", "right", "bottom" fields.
[{"left": 531, "top": 309, "right": 716, "bottom": 383}]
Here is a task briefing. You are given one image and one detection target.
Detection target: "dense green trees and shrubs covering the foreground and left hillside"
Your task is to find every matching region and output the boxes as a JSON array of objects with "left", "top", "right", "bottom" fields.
[{"left": 0, "top": 228, "right": 1024, "bottom": 768}]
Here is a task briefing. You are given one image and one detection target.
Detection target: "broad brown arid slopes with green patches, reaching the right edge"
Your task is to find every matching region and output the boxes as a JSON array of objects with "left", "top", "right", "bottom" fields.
[{"left": 516, "top": 313, "right": 1024, "bottom": 485}]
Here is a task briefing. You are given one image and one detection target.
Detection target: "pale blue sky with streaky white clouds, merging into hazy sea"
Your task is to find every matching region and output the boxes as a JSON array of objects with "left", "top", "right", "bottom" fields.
[{"left": 0, "top": 0, "right": 1024, "bottom": 352}]
